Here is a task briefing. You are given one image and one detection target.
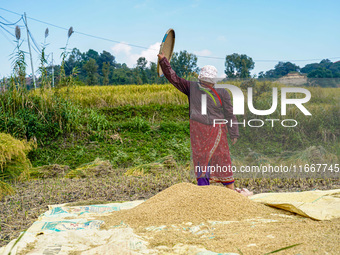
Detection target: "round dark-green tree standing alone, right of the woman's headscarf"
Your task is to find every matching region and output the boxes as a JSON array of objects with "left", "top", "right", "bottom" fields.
[{"left": 224, "top": 53, "right": 255, "bottom": 78}]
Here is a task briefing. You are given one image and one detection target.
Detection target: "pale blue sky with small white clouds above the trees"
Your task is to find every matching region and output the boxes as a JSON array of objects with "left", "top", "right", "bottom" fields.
[{"left": 0, "top": 0, "right": 340, "bottom": 78}]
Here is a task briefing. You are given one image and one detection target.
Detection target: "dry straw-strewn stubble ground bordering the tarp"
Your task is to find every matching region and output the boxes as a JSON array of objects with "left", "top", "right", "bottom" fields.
[{"left": 0, "top": 172, "right": 340, "bottom": 247}]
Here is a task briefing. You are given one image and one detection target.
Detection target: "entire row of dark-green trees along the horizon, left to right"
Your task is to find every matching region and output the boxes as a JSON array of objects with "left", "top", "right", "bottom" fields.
[{"left": 27, "top": 48, "right": 340, "bottom": 86}]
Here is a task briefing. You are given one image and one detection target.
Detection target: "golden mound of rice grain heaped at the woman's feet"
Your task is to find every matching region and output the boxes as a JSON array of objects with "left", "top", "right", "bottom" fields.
[{"left": 101, "top": 183, "right": 277, "bottom": 227}]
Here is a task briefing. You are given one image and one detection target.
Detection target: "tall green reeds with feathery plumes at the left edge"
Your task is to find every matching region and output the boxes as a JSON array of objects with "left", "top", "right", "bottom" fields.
[{"left": 0, "top": 24, "right": 113, "bottom": 141}]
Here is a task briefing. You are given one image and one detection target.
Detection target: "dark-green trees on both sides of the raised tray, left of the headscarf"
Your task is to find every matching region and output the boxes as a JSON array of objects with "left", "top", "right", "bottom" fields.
[{"left": 47, "top": 48, "right": 198, "bottom": 85}]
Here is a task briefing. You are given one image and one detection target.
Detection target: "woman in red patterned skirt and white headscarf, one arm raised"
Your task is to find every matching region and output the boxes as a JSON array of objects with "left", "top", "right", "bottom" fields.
[{"left": 158, "top": 53, "right": 252, "bottom": 196}]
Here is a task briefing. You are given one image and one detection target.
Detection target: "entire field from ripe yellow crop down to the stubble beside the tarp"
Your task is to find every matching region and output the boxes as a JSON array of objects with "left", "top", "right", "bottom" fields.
[{"left": 0, "top": 81, "right": 340, "bottom": 249}]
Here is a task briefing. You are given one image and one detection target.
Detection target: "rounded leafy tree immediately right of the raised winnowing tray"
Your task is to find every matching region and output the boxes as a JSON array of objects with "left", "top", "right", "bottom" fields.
[{"left": 171, "top": 51, "right": 199, "bottom": 77}]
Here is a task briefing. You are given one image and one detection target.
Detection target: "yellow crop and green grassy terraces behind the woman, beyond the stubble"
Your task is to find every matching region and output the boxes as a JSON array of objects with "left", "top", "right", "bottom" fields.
[{"left": 27, "top": 82, "right": 340, "bottom": 167}]
